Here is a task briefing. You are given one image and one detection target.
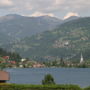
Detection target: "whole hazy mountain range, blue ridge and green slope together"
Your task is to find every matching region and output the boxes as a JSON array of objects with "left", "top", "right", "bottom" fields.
[{"left": 0, "top": 15, "right": 90, "bottom": 60}]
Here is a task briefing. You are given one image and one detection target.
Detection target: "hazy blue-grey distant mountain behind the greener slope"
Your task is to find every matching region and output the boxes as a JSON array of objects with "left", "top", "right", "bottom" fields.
[{"left": 0, "top": 14, "right": 62, "bottom": 39}]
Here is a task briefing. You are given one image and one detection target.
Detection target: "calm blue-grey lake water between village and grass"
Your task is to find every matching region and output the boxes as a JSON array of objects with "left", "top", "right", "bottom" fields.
[{"left": 7, "top": 68, "right": 90, "bottom": 87}]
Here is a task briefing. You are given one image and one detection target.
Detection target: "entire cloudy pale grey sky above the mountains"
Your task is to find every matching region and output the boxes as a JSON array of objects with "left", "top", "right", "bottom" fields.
[{"left": 0, "top": 0, "right": 90, "bottom": 19}]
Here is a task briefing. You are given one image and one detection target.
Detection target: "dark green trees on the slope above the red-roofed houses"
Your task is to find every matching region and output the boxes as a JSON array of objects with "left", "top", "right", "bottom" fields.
[{"left": 0, "top": 48, "right": 21, "bottom": 62}]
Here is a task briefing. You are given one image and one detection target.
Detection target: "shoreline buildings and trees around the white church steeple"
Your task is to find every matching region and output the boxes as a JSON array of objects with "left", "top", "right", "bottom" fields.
[{"left": 45, "top": 54, "right": 90, "bottom": 68}]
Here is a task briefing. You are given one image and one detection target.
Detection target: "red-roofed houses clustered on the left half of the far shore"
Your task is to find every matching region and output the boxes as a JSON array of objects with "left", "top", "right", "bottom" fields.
[{"left": 0, "top": 56, "right": 45, "bottom": 68}]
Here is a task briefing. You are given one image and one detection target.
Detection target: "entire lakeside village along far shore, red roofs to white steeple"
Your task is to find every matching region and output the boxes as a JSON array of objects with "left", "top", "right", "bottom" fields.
[{"left": 0, "top": 54, "right": 90, "bottom": 69}]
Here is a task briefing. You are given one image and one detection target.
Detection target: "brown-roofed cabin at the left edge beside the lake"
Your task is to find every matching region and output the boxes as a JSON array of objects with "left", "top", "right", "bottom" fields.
[{"left": 0, "top": 71, "right": 10, "bottom": 83}]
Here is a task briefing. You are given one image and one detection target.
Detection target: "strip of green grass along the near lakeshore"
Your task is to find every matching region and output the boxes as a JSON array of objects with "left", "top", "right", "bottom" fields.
[{"left": 0, "top": 84, "right": 90, "bottom": 90}]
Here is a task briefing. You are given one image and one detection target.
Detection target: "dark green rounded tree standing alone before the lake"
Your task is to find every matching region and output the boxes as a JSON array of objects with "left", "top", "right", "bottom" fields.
[{"left": 42, "top": 74, "right": 55, "bottom": 85}]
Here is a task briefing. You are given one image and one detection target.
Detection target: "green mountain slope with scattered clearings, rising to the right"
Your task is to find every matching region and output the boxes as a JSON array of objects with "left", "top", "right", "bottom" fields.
[{"left": 4, "top": 17, "right": 90, "bottom": 60}]
